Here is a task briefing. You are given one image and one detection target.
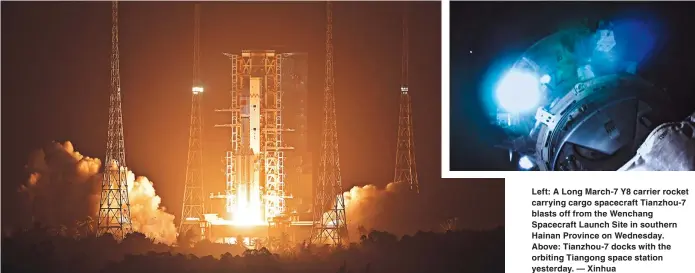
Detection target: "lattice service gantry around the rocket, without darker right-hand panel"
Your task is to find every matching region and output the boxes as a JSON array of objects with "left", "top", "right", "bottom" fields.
[{"left": 216, "top": 50, "right": 292, "bottom": 223}]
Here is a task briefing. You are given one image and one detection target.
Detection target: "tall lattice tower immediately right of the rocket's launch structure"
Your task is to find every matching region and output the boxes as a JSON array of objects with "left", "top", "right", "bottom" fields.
[{"left": 310, "top": 2, "right": 349, "bottom": 245}]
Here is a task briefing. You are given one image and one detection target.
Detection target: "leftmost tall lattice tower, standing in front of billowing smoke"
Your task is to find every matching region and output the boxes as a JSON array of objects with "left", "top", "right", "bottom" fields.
[{"left": 97, "top": 1, "right": 132, "bottom": 240}]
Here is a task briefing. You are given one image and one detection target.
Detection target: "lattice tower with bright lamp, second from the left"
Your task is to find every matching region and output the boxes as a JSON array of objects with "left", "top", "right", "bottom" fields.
[{"left": 179, "top": 4, "right": 205, "bottom": 238}]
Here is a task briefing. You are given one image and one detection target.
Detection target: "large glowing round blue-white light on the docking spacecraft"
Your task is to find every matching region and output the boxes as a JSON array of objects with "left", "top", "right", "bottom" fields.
[{"left": 496, "top": 70, "right": 541, "bottom": 113}]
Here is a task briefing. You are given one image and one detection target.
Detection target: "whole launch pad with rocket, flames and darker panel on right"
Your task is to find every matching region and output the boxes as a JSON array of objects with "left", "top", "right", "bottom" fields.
[{"left": 201, "top": 50, "right": 312, "bottom": 245}]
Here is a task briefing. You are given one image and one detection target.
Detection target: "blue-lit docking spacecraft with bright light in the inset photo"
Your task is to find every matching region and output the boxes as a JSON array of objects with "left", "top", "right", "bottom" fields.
[{"left": 495, "top": 21, "right": 693, "bottom": 171}]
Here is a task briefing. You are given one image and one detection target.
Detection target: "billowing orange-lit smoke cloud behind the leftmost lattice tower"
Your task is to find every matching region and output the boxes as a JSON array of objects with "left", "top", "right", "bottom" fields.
[{"left": 19, "top": 141, "right": 176, "bottom": 244}]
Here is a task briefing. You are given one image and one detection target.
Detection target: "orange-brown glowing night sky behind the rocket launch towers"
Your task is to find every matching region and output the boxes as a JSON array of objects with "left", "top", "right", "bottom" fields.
[{"left": 2, "top": 2, "right": 504, "bottom": 230}]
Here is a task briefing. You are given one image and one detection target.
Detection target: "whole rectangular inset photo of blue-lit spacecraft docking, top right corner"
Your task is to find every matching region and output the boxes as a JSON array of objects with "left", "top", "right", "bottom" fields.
[{"left": 443, "top": 1, "right": 695, "bottom": 171}]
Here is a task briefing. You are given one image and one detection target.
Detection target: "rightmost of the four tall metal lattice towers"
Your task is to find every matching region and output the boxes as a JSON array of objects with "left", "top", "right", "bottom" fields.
[{"left": 393, "top": 4, "right": 420, "bottom": 193}]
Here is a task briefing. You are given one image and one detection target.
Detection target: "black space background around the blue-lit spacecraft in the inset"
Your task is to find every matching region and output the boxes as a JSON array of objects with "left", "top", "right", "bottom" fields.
[{"left": 450, "top": 1, "right": 695, "bottom": 170}]
